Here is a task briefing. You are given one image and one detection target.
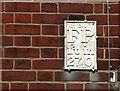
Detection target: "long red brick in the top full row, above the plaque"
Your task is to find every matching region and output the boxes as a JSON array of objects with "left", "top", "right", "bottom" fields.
[{"left": 59, "top": 3, "right": 93, "bottom": 13}]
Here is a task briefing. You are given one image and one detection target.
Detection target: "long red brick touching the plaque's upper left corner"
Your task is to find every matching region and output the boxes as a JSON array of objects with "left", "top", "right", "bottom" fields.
[{"left": 33, "top": 14, "right": 67, "bottom": 24}]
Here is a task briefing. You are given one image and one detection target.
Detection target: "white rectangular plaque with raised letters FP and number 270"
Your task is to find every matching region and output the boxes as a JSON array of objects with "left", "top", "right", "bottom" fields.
[{"left": 64, "top": 20, "right": 97, "bottom": 70}]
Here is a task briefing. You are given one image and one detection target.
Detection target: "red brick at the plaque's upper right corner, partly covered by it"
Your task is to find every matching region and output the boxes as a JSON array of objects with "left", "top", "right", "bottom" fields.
[{"left": 86, "top": 15, "right": 107, "bottom": 25}]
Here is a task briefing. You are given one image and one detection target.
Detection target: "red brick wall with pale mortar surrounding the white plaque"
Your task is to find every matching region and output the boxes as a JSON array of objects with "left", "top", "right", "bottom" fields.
[{"left": 2, "top": 2, "right": 120, "bottom": 91}]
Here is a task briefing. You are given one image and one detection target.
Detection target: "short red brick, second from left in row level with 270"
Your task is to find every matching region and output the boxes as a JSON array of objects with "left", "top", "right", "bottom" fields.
[{"left": 15, "top": 60, "right": 31, "bottom": 69}]
